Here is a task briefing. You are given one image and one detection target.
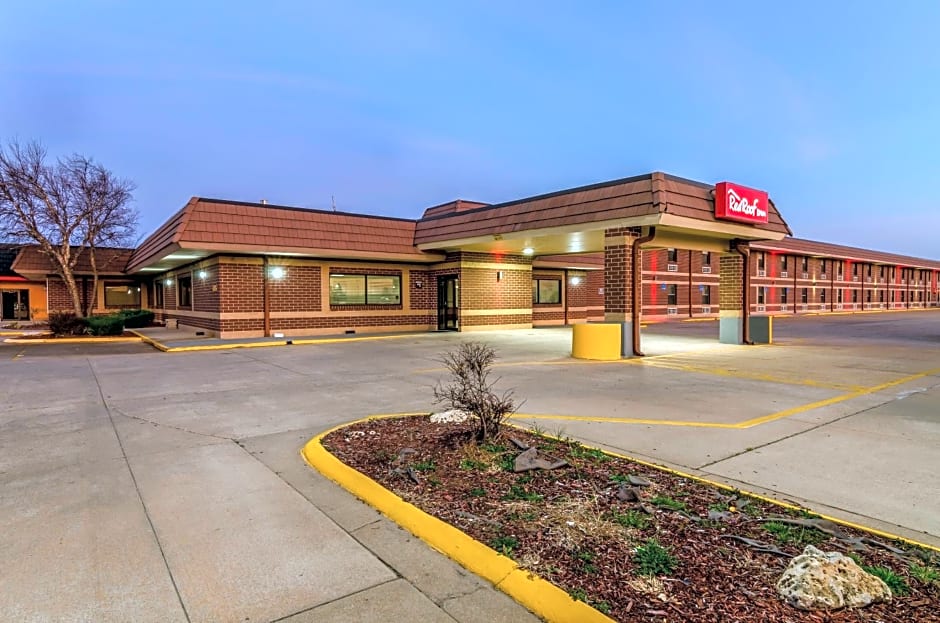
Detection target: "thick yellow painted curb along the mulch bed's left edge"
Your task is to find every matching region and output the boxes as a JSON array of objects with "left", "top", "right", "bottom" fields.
[{"left": 301, "top": 413, "right": 613, "bottom": 623}]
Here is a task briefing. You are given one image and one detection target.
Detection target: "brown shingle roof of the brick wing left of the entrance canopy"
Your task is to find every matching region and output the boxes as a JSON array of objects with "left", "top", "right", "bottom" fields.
[{"left": 128, "top": 197, "right": 441, "bottom": 271}]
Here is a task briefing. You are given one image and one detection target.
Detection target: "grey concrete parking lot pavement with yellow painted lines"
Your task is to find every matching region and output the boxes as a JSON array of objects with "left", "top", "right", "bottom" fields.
[{"left": 0, "top": 311, "right": 940, "bottom": 621}]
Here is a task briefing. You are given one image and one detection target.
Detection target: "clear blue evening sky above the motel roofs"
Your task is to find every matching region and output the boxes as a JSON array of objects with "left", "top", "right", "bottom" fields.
[{"left": 0, "top": 0, "right": 940, "bottom": 258}]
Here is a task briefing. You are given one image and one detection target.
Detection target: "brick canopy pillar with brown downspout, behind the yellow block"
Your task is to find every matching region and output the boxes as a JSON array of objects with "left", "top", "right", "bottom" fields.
[{"left": 604, "top": 227, "right": 643, "bottom": 357}]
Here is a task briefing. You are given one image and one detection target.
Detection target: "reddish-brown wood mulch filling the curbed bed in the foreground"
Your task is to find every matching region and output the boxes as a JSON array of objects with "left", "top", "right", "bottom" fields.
[{"left": 323, "top": 417, "right": 940, "bottom": 623}]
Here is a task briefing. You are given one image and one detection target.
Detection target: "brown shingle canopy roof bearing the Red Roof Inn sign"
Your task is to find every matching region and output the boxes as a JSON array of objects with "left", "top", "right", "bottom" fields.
[{"left": 415, "top": 173, "right": 791, "bottom": 245}]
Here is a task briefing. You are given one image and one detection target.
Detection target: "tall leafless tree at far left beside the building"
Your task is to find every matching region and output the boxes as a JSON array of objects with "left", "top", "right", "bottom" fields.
[{"left": 0, "top": 141, "right": 137, "bottom": 316}]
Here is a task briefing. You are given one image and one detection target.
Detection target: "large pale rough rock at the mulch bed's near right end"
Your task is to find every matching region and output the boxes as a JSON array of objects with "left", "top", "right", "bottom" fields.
[{"left": 777, "top": 545, "right": 891, "bottom": 610}]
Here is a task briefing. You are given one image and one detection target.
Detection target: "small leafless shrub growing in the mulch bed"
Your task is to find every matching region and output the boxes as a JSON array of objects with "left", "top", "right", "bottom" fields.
[{"left": 434, "top": 342, "right": 516, "bottom": 442}]
